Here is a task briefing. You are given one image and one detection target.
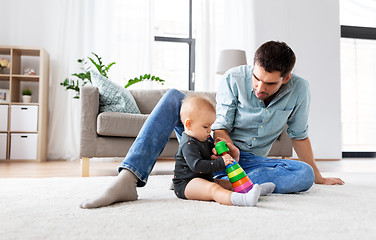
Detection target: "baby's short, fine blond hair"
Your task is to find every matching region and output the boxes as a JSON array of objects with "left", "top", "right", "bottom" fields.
[{"left": 180, "top": 93, "right": 215, "bottom": 123}]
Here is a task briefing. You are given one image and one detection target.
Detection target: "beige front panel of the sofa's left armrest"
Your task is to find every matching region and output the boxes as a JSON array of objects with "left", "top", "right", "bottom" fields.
[{"left": 80, "top": 86, "right": 99, "bottom": 157}]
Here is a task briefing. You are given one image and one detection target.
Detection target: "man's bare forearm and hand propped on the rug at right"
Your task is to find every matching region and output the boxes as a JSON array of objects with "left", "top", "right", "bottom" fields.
[{"left": 291, "top": 137, "right": 344, "bottom": 185}]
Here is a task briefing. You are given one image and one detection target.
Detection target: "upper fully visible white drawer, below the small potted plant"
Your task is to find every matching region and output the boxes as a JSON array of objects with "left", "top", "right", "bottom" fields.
[{"left": 10, "top": 105, "right": 38, "bottom": 132}]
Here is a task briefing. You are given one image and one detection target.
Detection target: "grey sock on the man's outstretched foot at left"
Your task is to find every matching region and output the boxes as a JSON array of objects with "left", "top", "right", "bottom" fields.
[{"left": 80, "top": 169, "right": 138, "bottom": 208}]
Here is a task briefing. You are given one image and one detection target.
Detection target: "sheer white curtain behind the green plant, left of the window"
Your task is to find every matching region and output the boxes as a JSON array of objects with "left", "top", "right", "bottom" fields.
[{"left": 48, "top": 0, "right": 152, "bottom": 160}]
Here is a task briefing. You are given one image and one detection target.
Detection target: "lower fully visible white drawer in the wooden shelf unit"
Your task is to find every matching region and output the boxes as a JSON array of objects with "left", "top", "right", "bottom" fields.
[{"left": 10, "top": 133, "right": 38, "bottom": 159}]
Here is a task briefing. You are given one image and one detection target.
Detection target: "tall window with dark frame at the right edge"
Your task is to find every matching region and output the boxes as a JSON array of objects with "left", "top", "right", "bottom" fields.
[{"left": 340, "top": 0, "right": 376, "bottom": 157}]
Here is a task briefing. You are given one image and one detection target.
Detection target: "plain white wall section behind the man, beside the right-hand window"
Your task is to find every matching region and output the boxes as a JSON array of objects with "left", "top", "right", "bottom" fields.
[{"left": 252, "top": 0, "right": 342, "bottom": 159}]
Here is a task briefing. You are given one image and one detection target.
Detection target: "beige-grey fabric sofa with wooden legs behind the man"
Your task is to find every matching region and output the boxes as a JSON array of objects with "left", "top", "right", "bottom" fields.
[{"left": 80, "top": 86, "right": 292, "bottom": 177}]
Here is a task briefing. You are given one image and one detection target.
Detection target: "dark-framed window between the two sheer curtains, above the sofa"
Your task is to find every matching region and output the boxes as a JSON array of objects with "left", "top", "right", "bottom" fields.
[{"left": 153, "top": 0, "right": 195, "bottom": 90}]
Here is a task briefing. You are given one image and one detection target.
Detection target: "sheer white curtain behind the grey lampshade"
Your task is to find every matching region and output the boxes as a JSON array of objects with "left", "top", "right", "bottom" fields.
[{"left": 193, "top": 0, "right": 255, "bottom": 91}]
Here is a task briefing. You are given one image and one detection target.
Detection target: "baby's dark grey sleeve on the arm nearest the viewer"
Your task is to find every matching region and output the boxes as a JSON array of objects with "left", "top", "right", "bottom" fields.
[{"left": 181, "top": 141, "right": 226, "bottom": 174}]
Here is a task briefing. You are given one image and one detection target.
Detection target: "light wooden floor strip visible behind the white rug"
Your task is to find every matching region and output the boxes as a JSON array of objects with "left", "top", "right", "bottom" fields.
[{"left": 0, "top": 158, "right": 376, "bottom": 178}]
